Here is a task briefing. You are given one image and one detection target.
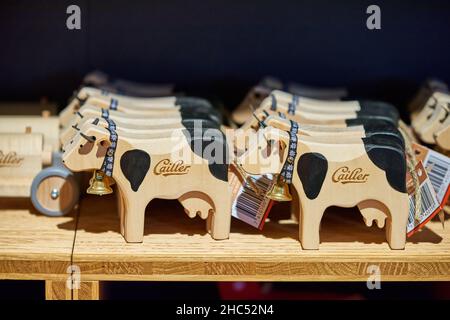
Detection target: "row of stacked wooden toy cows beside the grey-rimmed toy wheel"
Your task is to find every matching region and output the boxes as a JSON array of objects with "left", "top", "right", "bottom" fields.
[{"left": 60, "top": 83, "right": 231, "bottom": 242}]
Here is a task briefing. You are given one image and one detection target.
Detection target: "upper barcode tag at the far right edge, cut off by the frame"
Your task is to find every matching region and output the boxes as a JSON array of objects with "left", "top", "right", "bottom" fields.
[{"left": 423, "top": 150, "right": 450, "bottom": 204}]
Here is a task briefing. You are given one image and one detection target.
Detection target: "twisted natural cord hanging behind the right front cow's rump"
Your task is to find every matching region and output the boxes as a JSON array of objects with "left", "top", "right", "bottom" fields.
[{"left": 398, "top": 120, "right": 422, "bottom": 221}]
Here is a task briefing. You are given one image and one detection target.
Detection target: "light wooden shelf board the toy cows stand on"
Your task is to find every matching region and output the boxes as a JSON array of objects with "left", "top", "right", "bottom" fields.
[{"left": 0, "top": 196, "right": 450, "bottom": 291}]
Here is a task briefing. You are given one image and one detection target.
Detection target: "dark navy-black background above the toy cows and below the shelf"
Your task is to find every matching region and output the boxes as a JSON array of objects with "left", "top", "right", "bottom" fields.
[{"left": 0, "top": 0, "right": 450, "bottom": 299}]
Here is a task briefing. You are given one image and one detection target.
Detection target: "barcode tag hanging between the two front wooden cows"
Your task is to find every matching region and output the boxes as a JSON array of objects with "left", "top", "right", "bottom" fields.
[{"left": 231, "top": 175, "right": 273, "bottom": 229}]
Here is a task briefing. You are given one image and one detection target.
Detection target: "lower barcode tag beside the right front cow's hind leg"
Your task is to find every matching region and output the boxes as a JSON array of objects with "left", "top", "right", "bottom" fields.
[{"left": 407, "top": 172, "right": 439, "bottom": 236}]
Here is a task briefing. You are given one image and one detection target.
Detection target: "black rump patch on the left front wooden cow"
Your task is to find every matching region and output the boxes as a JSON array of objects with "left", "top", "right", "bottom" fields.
[{"left": 183, "top": 128, "right": 229, "bottom": 181}]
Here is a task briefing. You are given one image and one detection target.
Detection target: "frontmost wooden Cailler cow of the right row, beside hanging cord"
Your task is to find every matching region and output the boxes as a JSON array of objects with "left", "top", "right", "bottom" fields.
[{"left": 237, "top": 126, "right": 409, "bottom": 249}]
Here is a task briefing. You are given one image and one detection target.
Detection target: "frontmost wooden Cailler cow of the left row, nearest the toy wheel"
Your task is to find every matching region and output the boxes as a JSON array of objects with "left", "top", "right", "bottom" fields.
[{"left": 63, "top": 121, "right": 231, "bottom": 242}]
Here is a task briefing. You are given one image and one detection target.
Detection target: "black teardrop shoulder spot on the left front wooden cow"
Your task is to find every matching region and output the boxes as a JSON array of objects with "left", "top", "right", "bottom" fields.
[{"left": 120, "top": 149, "right": 150, "bottom": 192}]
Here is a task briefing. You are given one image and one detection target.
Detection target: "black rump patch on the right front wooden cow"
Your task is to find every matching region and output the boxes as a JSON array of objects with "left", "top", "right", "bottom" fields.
[{"left": 362, "top": 136, "right": 406, "bottom": 192}]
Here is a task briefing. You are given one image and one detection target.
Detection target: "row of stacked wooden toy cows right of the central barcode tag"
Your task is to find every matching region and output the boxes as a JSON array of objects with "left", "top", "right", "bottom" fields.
[{"left": 236, "top": 90, "right": 409, "bottom": 249}]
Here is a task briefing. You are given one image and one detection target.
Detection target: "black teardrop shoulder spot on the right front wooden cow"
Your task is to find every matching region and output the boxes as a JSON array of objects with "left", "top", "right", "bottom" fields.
[{"left": 297, "top": 152, "right": 328, "bottom": 200}]
